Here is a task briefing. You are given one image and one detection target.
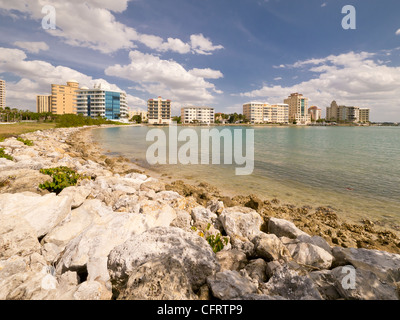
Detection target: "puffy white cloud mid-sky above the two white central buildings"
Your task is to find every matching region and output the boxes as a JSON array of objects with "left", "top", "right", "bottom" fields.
[{"left": 105, "top": 50, "right": 222, "bottom": 104}]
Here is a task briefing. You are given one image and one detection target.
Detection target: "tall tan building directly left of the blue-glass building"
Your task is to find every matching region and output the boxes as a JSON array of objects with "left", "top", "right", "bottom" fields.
[{"left": 51, "top": 80, "right": 79, "bottom": 114}]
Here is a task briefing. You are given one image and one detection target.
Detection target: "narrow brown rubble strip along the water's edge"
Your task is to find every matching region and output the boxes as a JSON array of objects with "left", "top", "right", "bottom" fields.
[{"left": 85, "top": 126, "right": 400, "bottom": 253}]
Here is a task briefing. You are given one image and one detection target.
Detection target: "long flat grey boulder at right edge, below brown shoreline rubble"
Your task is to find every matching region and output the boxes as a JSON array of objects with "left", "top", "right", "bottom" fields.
[{"left": 332, "top": 247, "right": 400, "bottom": 282}]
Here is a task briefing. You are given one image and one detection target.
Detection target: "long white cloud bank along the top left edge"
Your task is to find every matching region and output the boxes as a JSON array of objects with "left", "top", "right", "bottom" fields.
[{"left": 0, "top": 0, "right": 223, "bottom": 54}]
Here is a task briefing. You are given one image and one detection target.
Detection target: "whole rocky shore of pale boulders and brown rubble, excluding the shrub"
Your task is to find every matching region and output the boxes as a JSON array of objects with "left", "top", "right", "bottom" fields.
[{"left": 0, "top": 128, "right": 400, "bottom": 300}]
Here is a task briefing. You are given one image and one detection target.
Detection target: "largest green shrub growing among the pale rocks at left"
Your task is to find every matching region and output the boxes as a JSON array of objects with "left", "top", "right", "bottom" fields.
[{"left": 39, "top": 167, "right": 91, "bottom": 194}]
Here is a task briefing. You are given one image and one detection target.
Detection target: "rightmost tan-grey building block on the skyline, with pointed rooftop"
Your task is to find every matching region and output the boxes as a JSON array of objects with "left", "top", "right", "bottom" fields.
[{"left": 326, "top": 101, "right": 370, "bottom": 122}]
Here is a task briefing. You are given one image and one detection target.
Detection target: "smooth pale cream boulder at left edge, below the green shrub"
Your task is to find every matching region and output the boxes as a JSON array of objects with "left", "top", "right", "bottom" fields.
[{"left": 0, "top": 192, "right": 72, "bottom": 238}]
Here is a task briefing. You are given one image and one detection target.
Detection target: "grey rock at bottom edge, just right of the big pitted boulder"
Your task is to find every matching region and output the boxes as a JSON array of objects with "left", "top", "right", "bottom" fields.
[{"left": 207, "top": 270, "right": 258, "bottom": 300}]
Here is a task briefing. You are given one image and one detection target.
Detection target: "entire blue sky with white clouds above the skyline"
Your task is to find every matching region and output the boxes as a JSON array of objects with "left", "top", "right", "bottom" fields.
[{"left": 0, "top": 0, "right": 400, "bottom": 122}]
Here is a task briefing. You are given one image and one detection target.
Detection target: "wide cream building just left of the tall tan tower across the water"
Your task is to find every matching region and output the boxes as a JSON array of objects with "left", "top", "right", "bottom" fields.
[{"left": 243, "top": 102, "right": 289, "bottom": 124}]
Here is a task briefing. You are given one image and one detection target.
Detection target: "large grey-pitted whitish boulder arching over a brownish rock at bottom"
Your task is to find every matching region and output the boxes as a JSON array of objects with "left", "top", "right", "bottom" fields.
[{"left": 107, "top": 227, "right": 220, "bottom": 291}]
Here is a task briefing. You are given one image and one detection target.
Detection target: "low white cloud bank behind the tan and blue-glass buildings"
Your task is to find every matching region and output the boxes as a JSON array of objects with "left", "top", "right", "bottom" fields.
[{"left": 0, "top": 47, "right": 146, "bottom": 110}]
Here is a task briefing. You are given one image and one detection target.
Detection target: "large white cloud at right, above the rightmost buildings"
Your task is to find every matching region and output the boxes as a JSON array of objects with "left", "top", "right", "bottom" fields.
[{"left": 240, "top": 52, "right": 400, "bottom": 121}]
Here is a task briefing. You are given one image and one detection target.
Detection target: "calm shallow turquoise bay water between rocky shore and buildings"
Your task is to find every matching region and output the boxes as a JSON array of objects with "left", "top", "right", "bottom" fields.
[{"left": 93, "top": 127, "right": 400, "bottom": 232}]
